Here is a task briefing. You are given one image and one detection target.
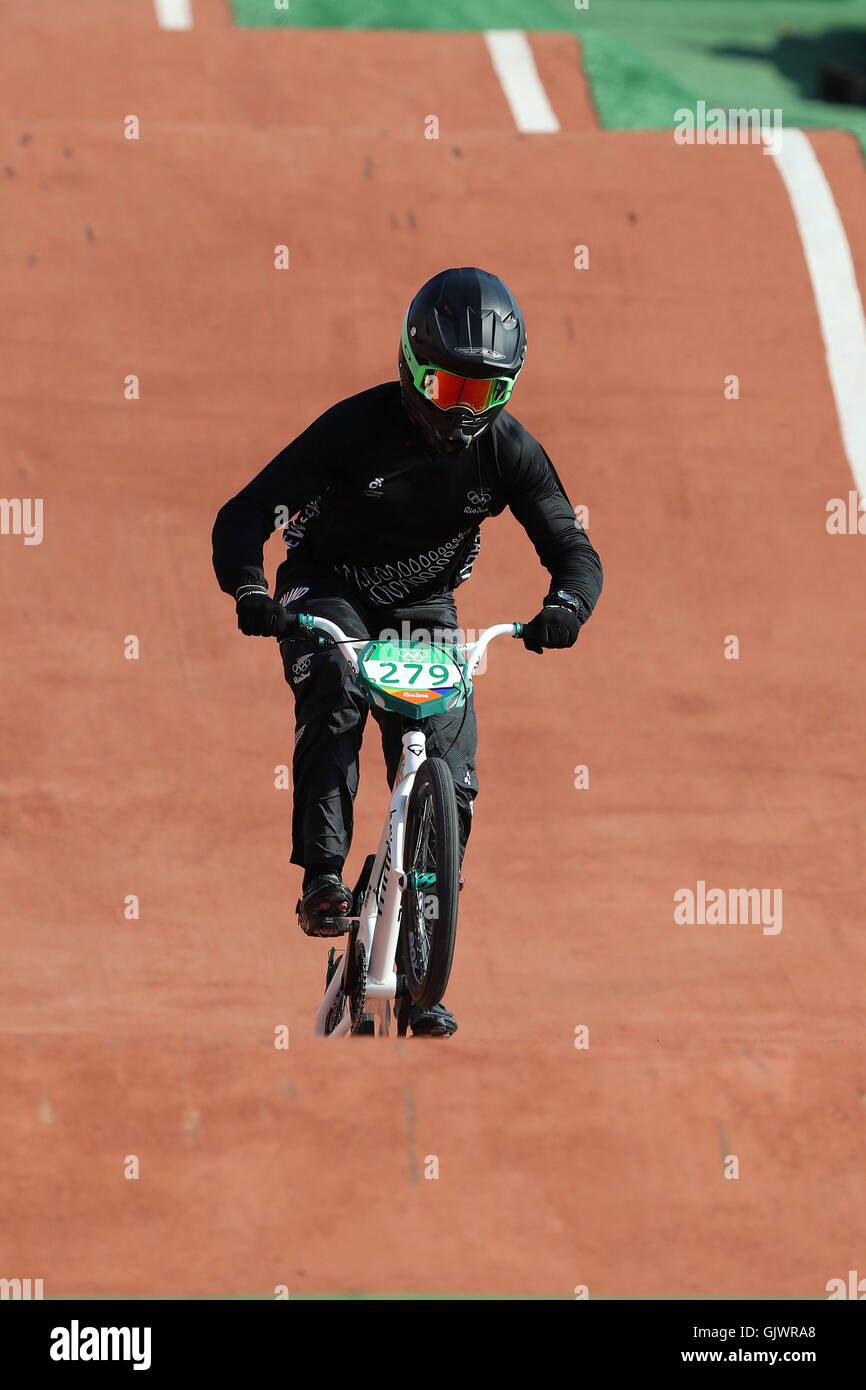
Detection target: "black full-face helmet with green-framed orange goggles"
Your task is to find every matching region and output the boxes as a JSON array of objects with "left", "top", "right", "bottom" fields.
[{"left": 399, "top": 267, "right": 527, "bottom": 455}]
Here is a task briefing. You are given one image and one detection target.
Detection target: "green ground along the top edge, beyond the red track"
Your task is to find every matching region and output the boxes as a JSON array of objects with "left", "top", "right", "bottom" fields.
[{"left": 226, "top": 0, "right": 866, "bottom": 150}]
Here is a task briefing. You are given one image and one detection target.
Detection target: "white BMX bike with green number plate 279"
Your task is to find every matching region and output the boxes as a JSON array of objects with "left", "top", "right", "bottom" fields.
[{"left": 284, "top": 613, "right": 524, "bottom": 1037}]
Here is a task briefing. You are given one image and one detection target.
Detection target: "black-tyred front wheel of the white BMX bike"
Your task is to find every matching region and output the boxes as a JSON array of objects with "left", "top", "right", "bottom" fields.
[{"left": 400, "top": 758, "right": 460, "bottom": 1008}]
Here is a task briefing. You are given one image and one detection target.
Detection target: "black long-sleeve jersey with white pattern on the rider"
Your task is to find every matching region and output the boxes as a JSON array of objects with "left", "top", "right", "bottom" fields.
[{"left": 213, "top": 381, "right": 602, "bottom": 619}]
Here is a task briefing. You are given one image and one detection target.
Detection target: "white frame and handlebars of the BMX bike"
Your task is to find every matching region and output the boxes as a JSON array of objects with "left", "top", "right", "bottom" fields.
[{"left": 302, "top": 614, "right": 523, "bottom": 1037}]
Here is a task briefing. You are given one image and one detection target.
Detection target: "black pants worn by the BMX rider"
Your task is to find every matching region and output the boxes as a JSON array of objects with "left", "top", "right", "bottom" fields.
[{"left": 277, "top": 555, "right": 478, "bottom": 872}]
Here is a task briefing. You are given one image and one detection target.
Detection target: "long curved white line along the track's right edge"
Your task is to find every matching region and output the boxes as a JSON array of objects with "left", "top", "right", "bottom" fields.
[{"left": 770, "top": 129, "right": 866, "bottom": 496}]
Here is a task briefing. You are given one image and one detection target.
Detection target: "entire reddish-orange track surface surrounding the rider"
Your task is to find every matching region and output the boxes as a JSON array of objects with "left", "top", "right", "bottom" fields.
[{"left": 0, "top": 0, "right": 866, "bottom": 1297}]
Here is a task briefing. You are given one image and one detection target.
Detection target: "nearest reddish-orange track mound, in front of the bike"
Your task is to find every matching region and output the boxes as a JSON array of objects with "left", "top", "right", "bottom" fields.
[{"left": 3, "top": 1030, "right": 862, "bottom": 1298}]
